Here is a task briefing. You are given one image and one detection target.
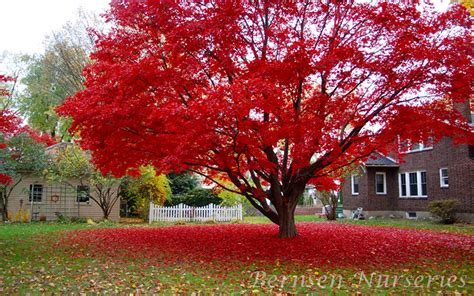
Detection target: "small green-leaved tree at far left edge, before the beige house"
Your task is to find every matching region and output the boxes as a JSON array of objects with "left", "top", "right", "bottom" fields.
[{"left": 0, "top": 132, "right": 49, "bottom": 221}]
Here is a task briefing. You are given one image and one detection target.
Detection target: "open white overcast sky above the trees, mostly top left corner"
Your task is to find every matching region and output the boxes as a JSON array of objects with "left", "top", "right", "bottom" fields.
[{"left": 0, "top": 0, "right": 449, "bottom": 54}]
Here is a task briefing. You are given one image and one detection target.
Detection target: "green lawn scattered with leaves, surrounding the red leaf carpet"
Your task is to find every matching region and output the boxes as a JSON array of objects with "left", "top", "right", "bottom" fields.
[{"left": 0, "top": 216, "right": 474, "bottom": 295}]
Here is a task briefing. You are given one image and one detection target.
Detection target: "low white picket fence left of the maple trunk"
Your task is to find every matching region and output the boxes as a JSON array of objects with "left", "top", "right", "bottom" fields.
[{"left": 149, "top": 203, "right": 242, "bottom": 223}]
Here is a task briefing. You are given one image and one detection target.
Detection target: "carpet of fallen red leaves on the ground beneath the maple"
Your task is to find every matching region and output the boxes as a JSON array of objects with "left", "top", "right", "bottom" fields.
[{"left": 58, "top": 223, "right": 474, "bottom": 269}]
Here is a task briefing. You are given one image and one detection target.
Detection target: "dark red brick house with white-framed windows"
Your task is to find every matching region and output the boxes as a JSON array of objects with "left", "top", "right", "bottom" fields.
[{"left": 342, "top": 138, "right": 474, "bottom": 221}]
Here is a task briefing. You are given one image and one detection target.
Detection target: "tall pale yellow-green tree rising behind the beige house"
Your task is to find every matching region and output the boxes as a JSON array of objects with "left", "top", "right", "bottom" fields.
[{"left": 18, "top": 10, "right": 103, "bottom": 140}]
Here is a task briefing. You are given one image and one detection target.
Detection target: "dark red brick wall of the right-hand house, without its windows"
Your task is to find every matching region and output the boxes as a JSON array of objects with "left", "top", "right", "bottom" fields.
[{"left": 343, "top": 138, "right": 474, "bottom": 213}]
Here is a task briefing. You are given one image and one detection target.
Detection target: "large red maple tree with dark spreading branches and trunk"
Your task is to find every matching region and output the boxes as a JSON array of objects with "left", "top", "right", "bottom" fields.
[{"left": 59, "top": 0, "right": 473, "bottom": 237}]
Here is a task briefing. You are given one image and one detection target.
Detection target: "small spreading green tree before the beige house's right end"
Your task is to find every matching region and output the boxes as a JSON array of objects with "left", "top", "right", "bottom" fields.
[{"left": 46, "top": 144, "right": 122, "bottom": 220}]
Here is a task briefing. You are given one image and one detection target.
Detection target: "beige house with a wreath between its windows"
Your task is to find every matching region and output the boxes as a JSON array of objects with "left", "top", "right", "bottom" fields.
[{"left": 8, "top": 143, "right": 120, "bottom": 221}]
